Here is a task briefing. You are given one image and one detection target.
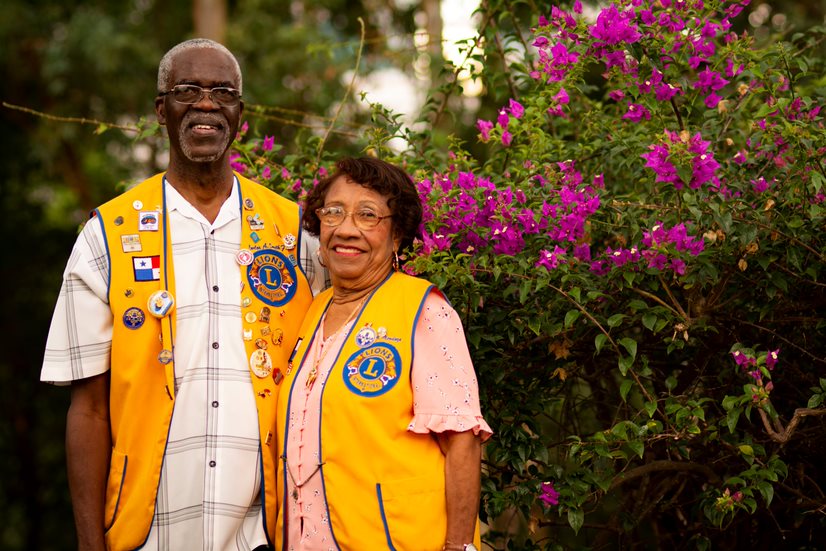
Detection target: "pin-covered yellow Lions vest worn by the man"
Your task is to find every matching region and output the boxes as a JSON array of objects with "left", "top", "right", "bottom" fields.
[{"left": 94, "top": 174, "right": 312, "bottom": 550}]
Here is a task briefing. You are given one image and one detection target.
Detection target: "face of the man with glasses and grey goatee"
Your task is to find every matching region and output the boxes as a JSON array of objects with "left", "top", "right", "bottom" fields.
[{"left": 155, "top": 48, "right": 244, "bottom": 165}]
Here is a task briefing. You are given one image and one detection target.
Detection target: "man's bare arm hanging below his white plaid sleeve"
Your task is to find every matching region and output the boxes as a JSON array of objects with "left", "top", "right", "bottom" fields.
[{"left": 66, "top": 372, "right": 112, "bottom": 551}]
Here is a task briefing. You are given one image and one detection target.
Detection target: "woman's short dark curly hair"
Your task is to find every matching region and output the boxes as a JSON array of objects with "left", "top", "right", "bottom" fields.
[{"left": 301, "top": 157, "right": 422, "bottom": 250}]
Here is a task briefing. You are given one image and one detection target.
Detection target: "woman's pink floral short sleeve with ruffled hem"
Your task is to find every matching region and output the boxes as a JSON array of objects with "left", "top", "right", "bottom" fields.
[{"left": 407, "top": 291, "right": 493, "bottom": 441}]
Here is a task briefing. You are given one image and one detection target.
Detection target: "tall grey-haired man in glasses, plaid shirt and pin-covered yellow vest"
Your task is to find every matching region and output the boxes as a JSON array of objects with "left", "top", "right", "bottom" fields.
[{"left": 41, "top": 39, "right": 324, "bottom": 550}]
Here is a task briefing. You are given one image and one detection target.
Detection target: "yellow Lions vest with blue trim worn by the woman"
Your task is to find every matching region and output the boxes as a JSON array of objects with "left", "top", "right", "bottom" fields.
[{"left": 276, "top": 273, "right": 479, "bottom": 551}]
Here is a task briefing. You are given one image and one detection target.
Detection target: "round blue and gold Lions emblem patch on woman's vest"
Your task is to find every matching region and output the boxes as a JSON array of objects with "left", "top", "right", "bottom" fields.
[{"left": 343, "top": 343, "right": 401, "bottom": 397}]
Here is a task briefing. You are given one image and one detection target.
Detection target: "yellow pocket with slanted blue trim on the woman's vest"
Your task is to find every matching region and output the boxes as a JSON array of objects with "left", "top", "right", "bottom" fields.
[{"left": 376, "top": 477, "right": 447, "bottom": 551}]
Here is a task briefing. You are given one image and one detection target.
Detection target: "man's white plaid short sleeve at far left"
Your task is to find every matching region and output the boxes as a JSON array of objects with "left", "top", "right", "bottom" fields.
[{"left": 40, "top": 218, "right": 113, "bottom": 385}]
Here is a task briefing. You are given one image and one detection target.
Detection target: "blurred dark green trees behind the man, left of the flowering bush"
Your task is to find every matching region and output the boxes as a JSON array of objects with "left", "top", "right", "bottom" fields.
[{"left": 0, "top": 0, "right": 826, "bottom": 550}]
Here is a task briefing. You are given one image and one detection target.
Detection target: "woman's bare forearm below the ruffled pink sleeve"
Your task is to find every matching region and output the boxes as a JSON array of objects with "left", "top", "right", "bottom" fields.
[{"left": 438, "top": 431, "right": 482, "bottom": 550}]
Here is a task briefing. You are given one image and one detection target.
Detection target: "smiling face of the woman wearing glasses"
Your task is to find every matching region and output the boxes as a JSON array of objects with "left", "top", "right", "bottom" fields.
[{"left": 320, "top": 176, "right": 399, "bottom": 291}]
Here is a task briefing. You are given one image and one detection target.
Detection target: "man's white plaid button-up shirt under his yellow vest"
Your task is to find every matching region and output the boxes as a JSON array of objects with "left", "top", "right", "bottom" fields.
[{"left": 40, "top": 179, "right": 328, "bottom": 551}]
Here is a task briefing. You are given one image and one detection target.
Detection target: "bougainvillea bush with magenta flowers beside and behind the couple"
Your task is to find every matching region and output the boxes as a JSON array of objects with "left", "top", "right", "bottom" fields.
[{"left": 236, "top": 0, "right": 826, "bottom": 550}]
